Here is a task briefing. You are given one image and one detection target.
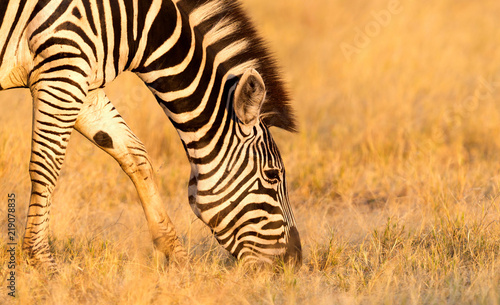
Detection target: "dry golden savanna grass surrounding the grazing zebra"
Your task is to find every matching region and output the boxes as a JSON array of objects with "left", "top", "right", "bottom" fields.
[{"left": 0, "top": 0, "right": 500, "bottom": 304}]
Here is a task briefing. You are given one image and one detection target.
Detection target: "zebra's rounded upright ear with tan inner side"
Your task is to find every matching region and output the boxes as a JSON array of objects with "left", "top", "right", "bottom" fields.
[{"left": 234, "top": 69, "right": 266, "bottom": 126}]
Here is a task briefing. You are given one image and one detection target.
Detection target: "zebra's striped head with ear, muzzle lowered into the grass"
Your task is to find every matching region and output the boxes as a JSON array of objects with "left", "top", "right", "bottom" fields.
[{"left": 189, "top": 69, "right": 302, "bottom": 265}]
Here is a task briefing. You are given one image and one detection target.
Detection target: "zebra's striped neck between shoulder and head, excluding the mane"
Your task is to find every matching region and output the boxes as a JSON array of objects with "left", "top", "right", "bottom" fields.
[{"left": 133, "top": 1, "right": 257, "bottom": 144}]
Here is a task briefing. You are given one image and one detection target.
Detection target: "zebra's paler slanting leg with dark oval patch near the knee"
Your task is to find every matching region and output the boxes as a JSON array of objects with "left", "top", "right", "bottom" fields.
[{"left": 75, "top": 89, "right": 187, "bottom": 263}]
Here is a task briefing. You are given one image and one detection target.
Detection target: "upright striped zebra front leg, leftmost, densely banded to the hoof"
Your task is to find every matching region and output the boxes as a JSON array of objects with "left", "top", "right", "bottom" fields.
[{"left": 23, "top": 82, "right": 86, "bottom": 273}]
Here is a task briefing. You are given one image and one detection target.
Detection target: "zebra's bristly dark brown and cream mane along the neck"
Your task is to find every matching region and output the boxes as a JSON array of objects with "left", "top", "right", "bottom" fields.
[{"left": 177, "top": 0, "right": 297, "bottom": 132}]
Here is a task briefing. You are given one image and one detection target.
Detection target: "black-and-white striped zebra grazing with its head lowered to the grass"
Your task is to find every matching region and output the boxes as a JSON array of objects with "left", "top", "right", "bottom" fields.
[{"left": 0, "top": 0, "right": 301, "bottom": 270}]
